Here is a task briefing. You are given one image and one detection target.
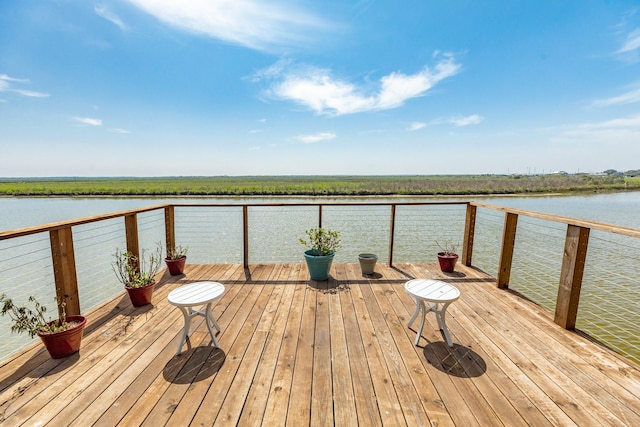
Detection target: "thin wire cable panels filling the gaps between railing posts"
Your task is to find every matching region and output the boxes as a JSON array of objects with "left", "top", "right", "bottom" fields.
[{"left": 0, "top": 204, "right": 640, "bottom": 360}]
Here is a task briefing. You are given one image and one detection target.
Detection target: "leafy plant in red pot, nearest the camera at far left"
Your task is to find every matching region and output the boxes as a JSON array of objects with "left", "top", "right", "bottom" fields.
[{"left": 0, "top": 294, "right": 87, "bottom": 359}]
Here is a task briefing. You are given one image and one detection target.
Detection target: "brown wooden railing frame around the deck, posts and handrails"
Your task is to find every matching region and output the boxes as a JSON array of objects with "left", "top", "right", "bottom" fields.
[{"left": 0, "top": 202, "right": 640, "bottom": 356}]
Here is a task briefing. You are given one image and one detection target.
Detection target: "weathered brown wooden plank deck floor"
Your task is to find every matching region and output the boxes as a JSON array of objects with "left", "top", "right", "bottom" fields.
[{"left": 0, "top": 264, "right": 640, "bottom": 427}]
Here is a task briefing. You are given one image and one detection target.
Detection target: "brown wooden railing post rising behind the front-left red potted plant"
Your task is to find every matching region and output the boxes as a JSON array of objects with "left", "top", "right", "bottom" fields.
[{"left": 49, "top": 227, "right": 80, "bottom": 316}]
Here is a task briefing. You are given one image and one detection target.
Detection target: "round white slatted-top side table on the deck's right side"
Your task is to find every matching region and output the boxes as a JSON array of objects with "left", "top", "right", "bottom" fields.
[{"left": 404, "top": 279, "right": 460, "bottom": 347}]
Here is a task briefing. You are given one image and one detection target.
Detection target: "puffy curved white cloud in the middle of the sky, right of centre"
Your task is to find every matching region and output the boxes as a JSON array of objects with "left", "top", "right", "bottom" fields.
[{"left": 256, "top": 56, "right": 461, "bottom": 115}]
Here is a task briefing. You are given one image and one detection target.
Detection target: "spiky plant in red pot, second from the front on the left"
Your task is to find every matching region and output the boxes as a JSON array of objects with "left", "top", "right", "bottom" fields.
[{"left": 111, "top": 244, "right": 162, "bottom": 307}]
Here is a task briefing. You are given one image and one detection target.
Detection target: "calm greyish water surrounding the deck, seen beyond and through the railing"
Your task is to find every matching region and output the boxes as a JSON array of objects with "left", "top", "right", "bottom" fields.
[{"left": 0, "top": 192, "right": 640, "bottom": 360}]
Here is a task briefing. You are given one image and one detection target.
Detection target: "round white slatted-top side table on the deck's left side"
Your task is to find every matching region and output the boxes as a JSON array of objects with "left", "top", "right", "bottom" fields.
[{"left": 167, "top": 282, "right": 224, "bottom": 354}]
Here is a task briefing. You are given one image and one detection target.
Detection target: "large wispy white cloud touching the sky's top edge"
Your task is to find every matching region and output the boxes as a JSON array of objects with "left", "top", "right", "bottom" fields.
[{"left": 129, "top": 0, "right": 335, "bottom": 50}]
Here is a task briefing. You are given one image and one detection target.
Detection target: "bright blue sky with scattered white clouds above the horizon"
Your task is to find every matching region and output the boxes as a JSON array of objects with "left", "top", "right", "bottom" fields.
[{"left": 0, "top": 0, "right": 640, "bottom": 177}]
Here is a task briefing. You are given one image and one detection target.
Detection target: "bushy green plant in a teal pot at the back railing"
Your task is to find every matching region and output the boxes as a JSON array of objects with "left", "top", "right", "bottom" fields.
[{"left": 299, "top": 227, "right": 340, "bottom": 280}]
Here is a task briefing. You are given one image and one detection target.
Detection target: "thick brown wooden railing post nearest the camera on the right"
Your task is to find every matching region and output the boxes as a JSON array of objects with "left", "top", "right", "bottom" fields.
[{"left": 554, "top": 225, "right": 591, "bottom": 330}]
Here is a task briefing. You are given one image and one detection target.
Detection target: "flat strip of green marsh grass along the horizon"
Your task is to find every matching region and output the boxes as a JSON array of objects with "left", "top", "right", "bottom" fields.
[{"left": 0, "top": 174, "right": 640, "bottom": 196}]
